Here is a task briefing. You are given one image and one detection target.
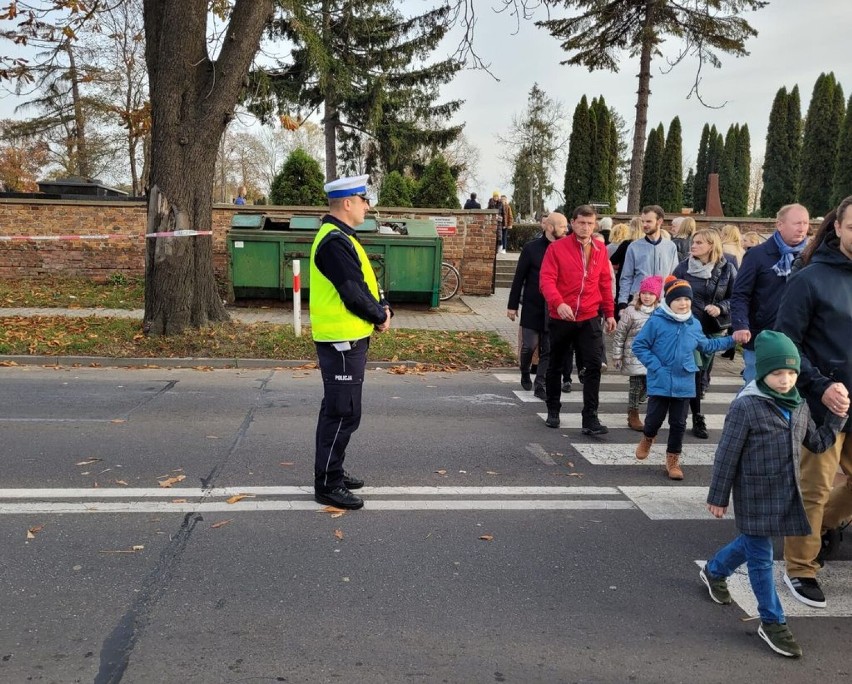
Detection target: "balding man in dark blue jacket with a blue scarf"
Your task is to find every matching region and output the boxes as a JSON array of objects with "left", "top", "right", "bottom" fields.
[{"left": 731, "top": 204, "right": 809, "bottom": 383}]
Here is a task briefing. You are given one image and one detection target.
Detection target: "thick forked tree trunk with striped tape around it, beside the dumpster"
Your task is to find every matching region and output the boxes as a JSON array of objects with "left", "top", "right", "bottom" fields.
[{"left": 144, "top": 0, "right": 273, "bottom": 335}]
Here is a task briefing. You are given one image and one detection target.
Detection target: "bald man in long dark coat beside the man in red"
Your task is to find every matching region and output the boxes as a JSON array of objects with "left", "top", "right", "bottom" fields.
[{"left": 506, "top": 212, "right": 568, "bottom": 401}]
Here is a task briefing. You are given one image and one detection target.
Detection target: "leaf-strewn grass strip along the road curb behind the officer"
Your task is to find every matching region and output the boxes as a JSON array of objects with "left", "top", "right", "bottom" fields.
[{"left": 0, "top": 316, "right": 515, "bottom": 369}]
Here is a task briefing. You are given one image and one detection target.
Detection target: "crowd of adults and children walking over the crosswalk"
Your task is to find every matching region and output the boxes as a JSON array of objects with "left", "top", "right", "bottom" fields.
[{"left": 508, "top": 197, "right": 852, "bottom": 657}]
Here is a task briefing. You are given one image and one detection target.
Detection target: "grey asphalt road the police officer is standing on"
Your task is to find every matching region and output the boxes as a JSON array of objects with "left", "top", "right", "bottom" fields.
[{"left": 0, "top": 367, "right": 852, "bottom": 684}]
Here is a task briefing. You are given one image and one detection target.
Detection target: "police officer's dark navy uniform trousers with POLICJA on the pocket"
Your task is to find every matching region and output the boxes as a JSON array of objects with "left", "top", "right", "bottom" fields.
[{"left": 314, "top": 337, "right": 370, "bottom": 490}]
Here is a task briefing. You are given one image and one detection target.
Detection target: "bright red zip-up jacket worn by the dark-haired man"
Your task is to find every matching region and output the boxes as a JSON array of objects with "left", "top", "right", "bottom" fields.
[{"left": 539, "top": 233, "right": 615, "bottom": 321}]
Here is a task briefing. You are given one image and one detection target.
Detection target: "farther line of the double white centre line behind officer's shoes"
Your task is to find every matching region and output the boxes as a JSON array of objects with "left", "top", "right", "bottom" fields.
[{"left": 0, "top": 485, "right": 621, "bottom": 501}]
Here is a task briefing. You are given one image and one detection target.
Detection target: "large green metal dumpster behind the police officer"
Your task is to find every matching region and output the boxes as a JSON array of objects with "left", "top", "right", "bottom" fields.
[{"left": 227, "top": 214, "right": 443, "bottom": 307}]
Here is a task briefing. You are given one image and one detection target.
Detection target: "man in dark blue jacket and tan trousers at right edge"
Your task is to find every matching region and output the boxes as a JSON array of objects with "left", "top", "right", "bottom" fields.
[{"left": 780, "top": 196, "right": 852, "bottom": 608}]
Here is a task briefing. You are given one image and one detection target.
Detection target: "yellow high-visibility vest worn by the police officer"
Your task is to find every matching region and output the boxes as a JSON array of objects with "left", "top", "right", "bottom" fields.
[{"left": 310, "top": 223, "right": 379, "bottom": 342}]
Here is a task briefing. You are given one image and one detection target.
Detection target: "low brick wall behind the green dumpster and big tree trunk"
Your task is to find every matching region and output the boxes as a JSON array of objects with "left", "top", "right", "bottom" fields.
[{"left": 0, "top": 199, "right": 496, "bottom": 295}]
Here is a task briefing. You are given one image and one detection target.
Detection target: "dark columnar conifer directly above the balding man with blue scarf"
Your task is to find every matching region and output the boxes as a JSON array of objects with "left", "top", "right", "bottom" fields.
[{"left": 760, "top": 88, "right": 801, "bottom": 217}]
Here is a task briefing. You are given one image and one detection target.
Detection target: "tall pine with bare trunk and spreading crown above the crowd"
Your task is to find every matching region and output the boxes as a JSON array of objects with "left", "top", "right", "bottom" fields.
[{"left": 537, "top": 0, "right": 767, "bottom": 212}]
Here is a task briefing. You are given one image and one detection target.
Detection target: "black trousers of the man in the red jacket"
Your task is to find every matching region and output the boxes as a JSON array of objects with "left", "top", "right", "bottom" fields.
[{"left": 547, "top": 316, "right": 603, "bottom": 427}]
